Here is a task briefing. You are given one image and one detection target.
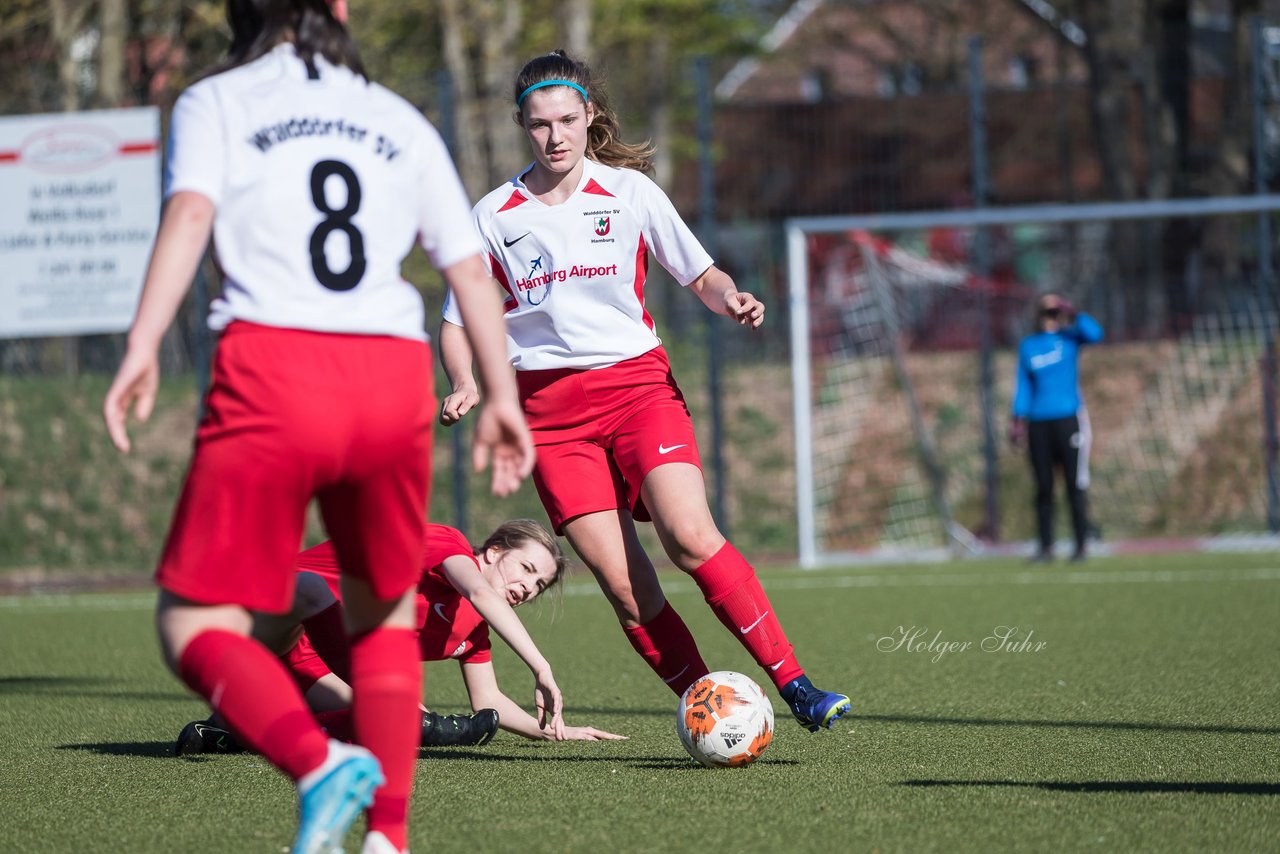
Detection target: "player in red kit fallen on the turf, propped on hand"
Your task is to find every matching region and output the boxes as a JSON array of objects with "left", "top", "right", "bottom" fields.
[{"left": 177, "top": 520, "right": 625, "bottom": 755}]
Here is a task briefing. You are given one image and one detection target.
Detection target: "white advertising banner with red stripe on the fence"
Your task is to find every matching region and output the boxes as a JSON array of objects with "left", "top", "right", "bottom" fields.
[{"left": 0, "top": 106, "right": 160, "bottom": 338}]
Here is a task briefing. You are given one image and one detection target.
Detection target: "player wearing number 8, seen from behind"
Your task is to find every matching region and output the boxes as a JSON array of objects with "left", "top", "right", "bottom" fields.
[{"left": 104, "top": 6, "right": 535, "bottom": 854}]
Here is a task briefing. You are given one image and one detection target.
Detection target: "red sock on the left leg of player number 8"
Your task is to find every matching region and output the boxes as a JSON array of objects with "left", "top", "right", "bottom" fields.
[{"left": 178, "top": 629, "right": 329, "bottom": 780}]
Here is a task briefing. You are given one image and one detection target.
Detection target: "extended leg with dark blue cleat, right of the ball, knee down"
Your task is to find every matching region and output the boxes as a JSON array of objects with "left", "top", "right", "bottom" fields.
[{"left": 640, "top": 462, "right": 850, "bottom": 731}]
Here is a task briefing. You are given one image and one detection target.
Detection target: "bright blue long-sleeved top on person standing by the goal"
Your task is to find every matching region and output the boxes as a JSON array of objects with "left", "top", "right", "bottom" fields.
[{"left": 1014, "top": 311, "right": 1102, "bottom": 421}]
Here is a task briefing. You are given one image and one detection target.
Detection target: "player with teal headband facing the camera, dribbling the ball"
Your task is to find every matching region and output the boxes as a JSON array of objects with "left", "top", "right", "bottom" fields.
[{"left": 440, "top": 51, "right": 850, "bottom": 731}]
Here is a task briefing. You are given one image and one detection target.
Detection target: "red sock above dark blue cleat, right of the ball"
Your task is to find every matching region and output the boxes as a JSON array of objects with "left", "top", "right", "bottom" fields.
[{"left": 691, "top": 543, "right": 804, "bottom": 689}]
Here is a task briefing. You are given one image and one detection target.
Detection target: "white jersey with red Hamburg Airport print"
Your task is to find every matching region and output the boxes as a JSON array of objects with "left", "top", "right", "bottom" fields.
[{"left": 444, "top": 160, "right": 712, "bottom": 370}]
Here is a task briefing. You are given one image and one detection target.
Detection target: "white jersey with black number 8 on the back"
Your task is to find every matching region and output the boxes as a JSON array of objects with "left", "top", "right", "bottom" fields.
[{"left": 165, "top": 44, "right": 481, "bottom": 339}]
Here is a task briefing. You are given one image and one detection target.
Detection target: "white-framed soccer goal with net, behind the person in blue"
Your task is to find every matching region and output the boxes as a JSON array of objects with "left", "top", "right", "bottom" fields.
[{"left": 788, "top": 197, "right": 1276, "bottom": 566}]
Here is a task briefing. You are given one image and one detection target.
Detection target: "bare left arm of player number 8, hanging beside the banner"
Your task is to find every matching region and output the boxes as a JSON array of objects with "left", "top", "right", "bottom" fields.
[{"left": 102, "top": 191, "right": 214, "bottom": 453}]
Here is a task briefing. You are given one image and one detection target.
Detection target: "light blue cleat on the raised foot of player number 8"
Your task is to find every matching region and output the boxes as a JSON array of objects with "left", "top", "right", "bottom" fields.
[{"left": 292, "top": 739, "right": 384, "bottom": 854}]
